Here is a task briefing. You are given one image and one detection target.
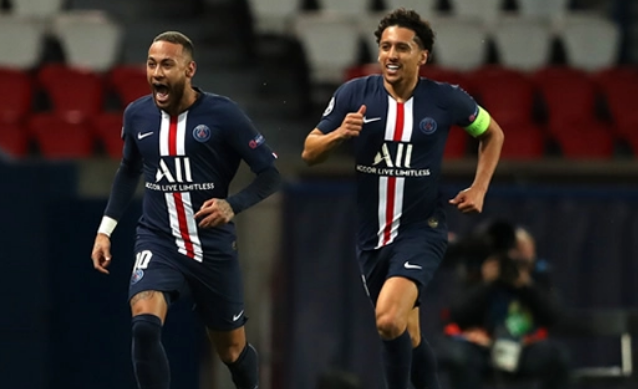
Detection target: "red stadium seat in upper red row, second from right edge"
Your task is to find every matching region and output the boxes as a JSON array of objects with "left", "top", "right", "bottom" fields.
[{"left": 533, "top": 66, "right": 596, "bottom": 129}]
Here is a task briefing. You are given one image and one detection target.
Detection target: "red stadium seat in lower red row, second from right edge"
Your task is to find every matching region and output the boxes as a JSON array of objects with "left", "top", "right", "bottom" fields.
[{"left": 550, "top": 120, "right": 614, "bottom": 159}]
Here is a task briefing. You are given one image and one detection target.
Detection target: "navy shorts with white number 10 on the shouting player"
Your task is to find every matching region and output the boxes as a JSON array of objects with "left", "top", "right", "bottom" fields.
[{"left": 129, "top": 236, "right": 246, "bottom": 331}]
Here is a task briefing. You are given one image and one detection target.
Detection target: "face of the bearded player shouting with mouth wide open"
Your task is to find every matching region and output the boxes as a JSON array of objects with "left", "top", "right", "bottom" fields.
[{"left": 146, "top": 41, "right": 192, "bottom": 111}]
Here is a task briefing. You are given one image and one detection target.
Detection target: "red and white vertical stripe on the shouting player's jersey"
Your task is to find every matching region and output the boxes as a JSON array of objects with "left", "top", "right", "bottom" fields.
[{"left": 159, "top": 111, "right": 203, "bottom": 262}]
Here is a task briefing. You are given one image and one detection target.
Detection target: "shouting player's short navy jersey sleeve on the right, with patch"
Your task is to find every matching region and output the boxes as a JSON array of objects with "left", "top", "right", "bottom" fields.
[{"left": 224, "top": 101, "right": 277, "bottom": 173}]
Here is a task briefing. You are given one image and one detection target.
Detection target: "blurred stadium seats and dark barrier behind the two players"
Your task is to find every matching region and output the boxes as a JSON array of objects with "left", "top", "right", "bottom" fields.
[{"left": 0, "top": 0, "right": 638, "bottom": 389}]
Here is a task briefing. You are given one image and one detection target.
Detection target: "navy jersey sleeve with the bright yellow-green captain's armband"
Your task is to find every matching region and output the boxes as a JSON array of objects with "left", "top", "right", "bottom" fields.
[{"left": 450, "top": 86, "right": 491, "bottom": 137}]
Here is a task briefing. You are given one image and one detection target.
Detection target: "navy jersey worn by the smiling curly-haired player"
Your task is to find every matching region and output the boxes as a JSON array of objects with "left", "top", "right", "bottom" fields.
[{"left": 317, "top": 75, "right": 479, "bottom": 250}]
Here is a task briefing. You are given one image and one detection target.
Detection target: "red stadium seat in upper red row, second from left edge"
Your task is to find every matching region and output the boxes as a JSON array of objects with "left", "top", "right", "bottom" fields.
[{"left": 38, "top": 64, "right": 104, "bottom": 123}]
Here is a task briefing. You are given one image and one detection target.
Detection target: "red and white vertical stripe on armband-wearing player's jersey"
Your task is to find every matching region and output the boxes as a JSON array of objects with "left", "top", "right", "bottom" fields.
[{"left": 377, "top": 96, "right": 413, "bottom": 248}]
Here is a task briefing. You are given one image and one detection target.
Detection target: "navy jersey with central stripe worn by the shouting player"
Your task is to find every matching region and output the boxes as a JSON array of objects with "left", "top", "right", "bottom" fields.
[{"left": 122, "top": 90, "right": 276, "bottom": 261}]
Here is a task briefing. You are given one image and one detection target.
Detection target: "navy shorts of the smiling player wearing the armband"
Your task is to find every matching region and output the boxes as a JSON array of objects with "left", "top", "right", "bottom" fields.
[{"left": 358, "top": 226, "right": 448, "bottom": 306}]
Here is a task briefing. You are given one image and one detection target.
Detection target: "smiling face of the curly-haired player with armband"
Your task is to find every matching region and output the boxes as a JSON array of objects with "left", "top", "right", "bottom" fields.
[{"left": 379, "top": 26, "right": 427, "bottom": 84}]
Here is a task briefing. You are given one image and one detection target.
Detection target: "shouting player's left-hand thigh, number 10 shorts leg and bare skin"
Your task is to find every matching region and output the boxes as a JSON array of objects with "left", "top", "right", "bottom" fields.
[{"left": 129, "top": 242, "right": 186, "bottom": 321}]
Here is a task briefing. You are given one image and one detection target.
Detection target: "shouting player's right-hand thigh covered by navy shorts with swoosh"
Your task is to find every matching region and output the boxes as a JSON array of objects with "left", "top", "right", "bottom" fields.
[{"left": 188, "top": 253, "right": 247, "bottom": 332}]
